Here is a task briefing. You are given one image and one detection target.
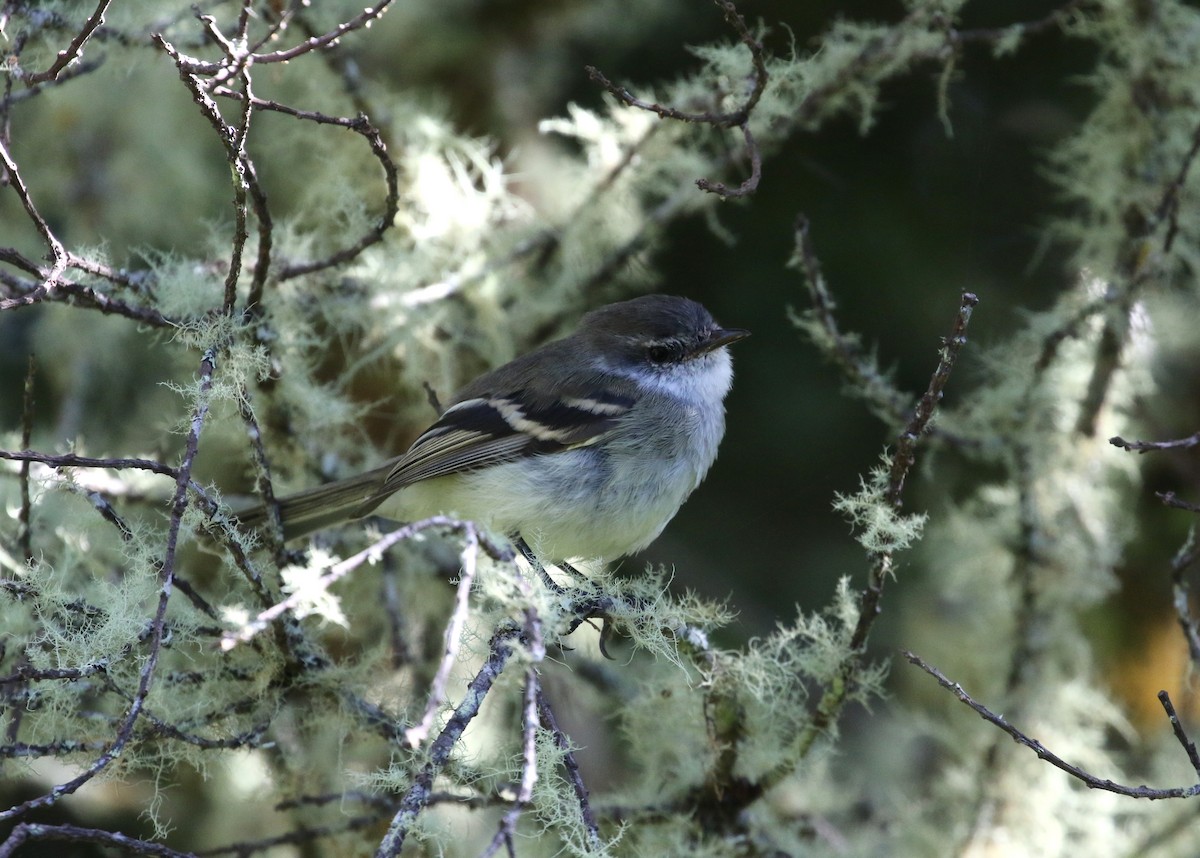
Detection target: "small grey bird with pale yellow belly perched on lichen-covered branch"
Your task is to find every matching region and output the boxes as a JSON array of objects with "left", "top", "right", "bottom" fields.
[{"left": 235, "top": 294, "right": 749, "bottom": 565}]
